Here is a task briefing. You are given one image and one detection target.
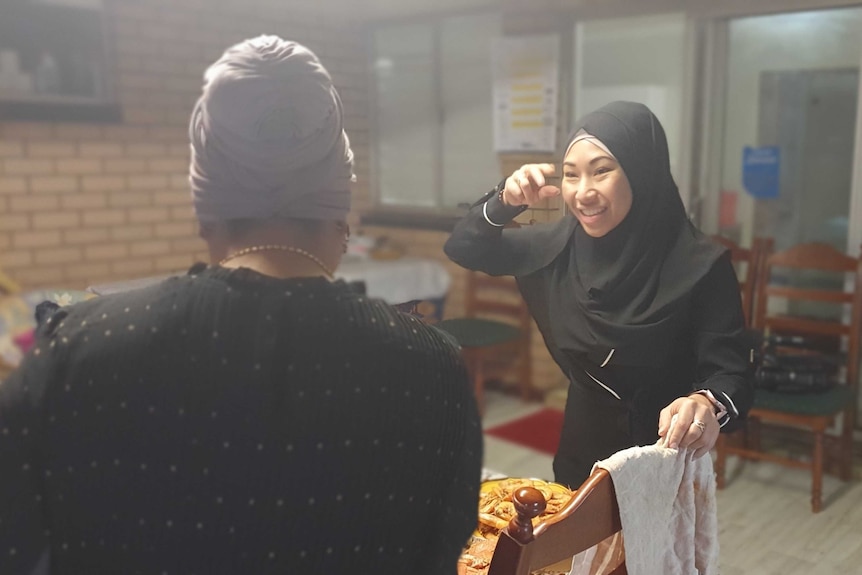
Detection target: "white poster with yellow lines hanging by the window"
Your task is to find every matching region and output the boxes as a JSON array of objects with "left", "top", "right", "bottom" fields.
[{"left": 491, "top": 35, "right": 560, "bottom": 152}]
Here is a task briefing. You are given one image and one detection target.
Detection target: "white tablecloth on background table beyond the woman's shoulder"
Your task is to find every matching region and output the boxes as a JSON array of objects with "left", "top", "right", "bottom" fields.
[{"left": 335, "top": 257, "right": 452, "bottom": 304}]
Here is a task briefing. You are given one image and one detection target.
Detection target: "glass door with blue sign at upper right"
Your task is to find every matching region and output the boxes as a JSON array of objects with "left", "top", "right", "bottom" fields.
[{"left": 706, "top": 8, "right": 862, "bottom": 256}]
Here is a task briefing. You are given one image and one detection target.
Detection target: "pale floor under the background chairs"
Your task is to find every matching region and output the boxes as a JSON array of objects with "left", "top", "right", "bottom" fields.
[{"left": 484, "top": 391, "right": 862, "bottom": 575}]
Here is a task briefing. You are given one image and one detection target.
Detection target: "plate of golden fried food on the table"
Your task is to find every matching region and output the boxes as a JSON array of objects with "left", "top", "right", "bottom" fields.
[{"left": 458, "top": 477, "right": 575, "bottom": 575}]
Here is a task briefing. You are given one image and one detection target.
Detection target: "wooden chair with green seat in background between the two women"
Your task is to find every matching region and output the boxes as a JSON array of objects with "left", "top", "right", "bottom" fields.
[{"left": 436, "top": 271, "right": 533, "bottom": 409}]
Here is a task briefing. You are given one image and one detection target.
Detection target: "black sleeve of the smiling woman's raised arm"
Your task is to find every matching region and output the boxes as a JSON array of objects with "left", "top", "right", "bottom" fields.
[{"left": 443, "top": 180, "right": 527, "bottom": 275}]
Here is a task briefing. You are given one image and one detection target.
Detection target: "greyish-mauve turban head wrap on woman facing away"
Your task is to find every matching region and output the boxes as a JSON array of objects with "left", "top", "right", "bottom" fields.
[{"left": 189, "top": 36, "right": 355, "bottom": 224}]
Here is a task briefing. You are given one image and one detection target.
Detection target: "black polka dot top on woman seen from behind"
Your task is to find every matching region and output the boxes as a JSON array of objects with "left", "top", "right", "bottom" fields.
[{"left": 0, "top": 266, "right": 482, "bottom": 575}]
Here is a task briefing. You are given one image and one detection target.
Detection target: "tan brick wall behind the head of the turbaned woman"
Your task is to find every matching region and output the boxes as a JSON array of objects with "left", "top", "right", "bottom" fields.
[{"left": 0, "top": 0, "right": 368, "bottom": 288}]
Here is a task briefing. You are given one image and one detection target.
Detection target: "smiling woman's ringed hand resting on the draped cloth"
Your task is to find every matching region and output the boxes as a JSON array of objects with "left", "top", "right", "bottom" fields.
[{"left": 658, "top": 394, "right": 720, "bottom": 459}]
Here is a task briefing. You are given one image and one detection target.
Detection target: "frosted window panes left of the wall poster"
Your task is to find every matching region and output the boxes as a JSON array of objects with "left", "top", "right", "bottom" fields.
[{"left": 373, "top": 15, "right": 501, "bottom": 210}]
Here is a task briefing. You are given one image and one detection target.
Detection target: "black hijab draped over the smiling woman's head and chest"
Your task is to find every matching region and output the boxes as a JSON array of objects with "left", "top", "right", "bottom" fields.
[{"left": 546, "top": 102, "right": 724, "bottom": 366}]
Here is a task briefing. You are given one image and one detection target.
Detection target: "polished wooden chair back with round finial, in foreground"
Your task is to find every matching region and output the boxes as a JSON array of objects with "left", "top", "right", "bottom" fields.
[{"left": 488, "top": 469, "right": 627, "bottom": 575}]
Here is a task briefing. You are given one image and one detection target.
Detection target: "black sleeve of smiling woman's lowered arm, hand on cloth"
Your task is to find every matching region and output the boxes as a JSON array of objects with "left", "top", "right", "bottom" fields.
[{"left": 692, "top": 255, "right": 754, "bottom": 431}]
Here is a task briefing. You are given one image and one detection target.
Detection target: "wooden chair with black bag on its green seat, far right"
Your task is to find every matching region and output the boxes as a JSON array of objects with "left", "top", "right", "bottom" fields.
[{"left": 716, "top": 243, "right": 862, "bottom": 513}]
